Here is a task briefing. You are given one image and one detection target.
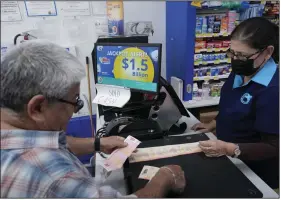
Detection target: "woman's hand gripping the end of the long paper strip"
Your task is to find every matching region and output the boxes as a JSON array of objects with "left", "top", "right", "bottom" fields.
[{"left": 199, "top": 140, "right": 236, "bottom": 157}]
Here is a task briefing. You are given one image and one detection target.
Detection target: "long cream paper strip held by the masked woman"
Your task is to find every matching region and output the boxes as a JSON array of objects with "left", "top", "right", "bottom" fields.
[{"left": 129, "top": 142, "right": 202, "bottom": 163}]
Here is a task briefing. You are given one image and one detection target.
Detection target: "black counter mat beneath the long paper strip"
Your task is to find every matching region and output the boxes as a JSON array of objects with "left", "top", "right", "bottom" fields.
[{"left": 124, "top": 134, "right": 263, "bottom": 198}]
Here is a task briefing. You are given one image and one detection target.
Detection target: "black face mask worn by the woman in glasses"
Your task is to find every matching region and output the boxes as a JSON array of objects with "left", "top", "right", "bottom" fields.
[{"left": 228, "top": 50, "right": 264, "bottom": 76}]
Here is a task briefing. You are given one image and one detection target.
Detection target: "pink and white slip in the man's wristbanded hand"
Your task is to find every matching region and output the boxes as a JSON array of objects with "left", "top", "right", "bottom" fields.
[{"left": 102, "top": 135, "right": 140, "bottom": 171}]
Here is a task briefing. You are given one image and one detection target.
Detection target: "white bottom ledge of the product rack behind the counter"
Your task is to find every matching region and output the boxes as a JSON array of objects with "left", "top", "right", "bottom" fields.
[{"left": 183, "top": 97, "right": 220, "bottom": 109}]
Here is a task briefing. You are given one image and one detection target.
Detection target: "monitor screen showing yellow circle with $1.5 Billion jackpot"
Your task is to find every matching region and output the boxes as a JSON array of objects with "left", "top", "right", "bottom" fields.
[{"left": 95, "top": 43, "right": 162, "bottom": 92}]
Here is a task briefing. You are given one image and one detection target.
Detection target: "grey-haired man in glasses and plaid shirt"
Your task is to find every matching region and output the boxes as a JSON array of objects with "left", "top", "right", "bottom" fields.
[{"left": 0, "top": 40, "right": 185, "bottom": 198}]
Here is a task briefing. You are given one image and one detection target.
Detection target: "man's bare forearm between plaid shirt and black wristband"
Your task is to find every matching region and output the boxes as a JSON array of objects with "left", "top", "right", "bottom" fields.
[{"left": 66, "top": 136, "right": 94, "bottom": 156}]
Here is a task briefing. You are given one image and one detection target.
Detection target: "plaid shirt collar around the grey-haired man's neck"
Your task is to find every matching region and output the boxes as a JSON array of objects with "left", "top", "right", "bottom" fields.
[{"left": 1, "top": 130, "right": 66, "bottom": 149}]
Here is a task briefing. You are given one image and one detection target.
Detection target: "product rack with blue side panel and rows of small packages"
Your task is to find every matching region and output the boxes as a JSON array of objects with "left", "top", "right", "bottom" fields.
[{"left": 166, "top": 1, "right": 279, "bottom": 104}]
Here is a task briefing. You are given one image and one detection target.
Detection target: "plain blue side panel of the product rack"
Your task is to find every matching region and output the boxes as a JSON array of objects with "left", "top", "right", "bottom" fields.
[{"left": 166, "top": 1, "right": 196, "bottom": 101}]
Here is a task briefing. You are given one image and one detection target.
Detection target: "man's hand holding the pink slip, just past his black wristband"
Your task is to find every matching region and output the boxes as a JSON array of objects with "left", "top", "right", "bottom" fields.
[{"left": 100, "top": 136, "right": 128, "bottom": 154}]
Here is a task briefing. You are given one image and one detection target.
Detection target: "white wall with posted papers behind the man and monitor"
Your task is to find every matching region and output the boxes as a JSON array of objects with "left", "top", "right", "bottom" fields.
[{"left": 1, "top": 1, "right": 166, "bottom": 116}]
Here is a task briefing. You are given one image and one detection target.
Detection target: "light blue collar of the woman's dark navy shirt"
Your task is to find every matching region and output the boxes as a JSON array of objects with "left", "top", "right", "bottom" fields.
[{"left": 233, "top": 58, "right": 277, "bottom": 89}]
